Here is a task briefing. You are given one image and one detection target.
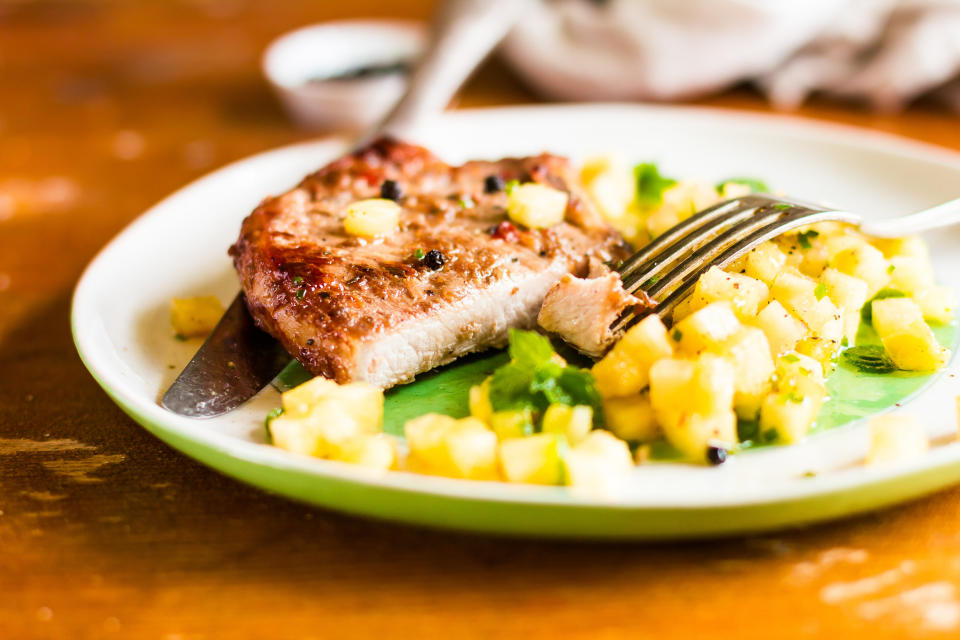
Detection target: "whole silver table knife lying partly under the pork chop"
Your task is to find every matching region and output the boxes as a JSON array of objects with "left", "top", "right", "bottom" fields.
[{"left": 160, "top": 0, "right": 529, "bottom": 418}]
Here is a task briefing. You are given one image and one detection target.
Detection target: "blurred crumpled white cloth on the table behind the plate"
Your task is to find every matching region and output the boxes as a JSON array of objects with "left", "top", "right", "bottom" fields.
[{"left": 502, "top": 0, "right": 960, "bottom": 112}]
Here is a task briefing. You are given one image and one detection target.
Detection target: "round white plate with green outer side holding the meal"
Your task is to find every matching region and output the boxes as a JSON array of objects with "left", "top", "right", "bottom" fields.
[{"left": 73, "top": 105, "right": 960, "bottom": 538}]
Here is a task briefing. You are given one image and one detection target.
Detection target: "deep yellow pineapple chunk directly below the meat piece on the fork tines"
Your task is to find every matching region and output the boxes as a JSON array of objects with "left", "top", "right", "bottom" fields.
[{"left": 592, "top": 314, "right": 673, "bottom": 398}]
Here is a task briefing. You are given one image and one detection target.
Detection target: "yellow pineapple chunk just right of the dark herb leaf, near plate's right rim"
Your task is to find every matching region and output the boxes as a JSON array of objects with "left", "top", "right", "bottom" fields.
[{"left": 871, "top": 298, "right": 950, "bottom": 371}]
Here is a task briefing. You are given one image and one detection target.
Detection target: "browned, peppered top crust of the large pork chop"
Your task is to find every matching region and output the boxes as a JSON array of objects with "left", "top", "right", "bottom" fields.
[{"left": 230, "top": 139, "right": 629, "bottom": 382}]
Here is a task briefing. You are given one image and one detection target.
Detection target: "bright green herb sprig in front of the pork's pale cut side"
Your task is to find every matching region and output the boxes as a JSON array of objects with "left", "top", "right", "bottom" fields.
[{"left": 490, "top": 329, "right": 603, "bottom": 426}]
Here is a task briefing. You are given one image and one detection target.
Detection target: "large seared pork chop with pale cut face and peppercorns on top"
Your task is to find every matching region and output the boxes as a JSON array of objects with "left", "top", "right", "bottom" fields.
[{"left": 230, "top": 139, "right": 629, "bottom": 388}]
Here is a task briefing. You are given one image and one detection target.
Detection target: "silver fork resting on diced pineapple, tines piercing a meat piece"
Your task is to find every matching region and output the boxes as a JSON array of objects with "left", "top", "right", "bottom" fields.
[{"left": 611, "top": 193, "right": 960, "bottom": 334}]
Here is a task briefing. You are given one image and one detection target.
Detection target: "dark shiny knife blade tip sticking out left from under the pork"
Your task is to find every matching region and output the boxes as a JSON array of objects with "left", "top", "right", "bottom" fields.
[{"left": 160, "top": 293, "right": 290, "bottom": 418}]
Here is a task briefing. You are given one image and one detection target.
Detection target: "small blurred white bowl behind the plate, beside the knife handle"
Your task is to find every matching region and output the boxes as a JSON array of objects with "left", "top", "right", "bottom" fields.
[{"left": 263, "top": 20, "right": 426, "bottom": 131}]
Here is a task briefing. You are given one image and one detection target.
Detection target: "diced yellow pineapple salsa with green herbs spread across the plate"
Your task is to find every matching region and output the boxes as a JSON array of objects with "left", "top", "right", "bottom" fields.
[{"left": 267, "top": 157, "right": 956, "bottom": 492}]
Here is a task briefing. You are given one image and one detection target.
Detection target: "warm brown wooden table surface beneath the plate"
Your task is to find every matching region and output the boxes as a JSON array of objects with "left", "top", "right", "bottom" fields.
[{"left": 0, "top": 0, "right": 960, "bottom": 640}]
